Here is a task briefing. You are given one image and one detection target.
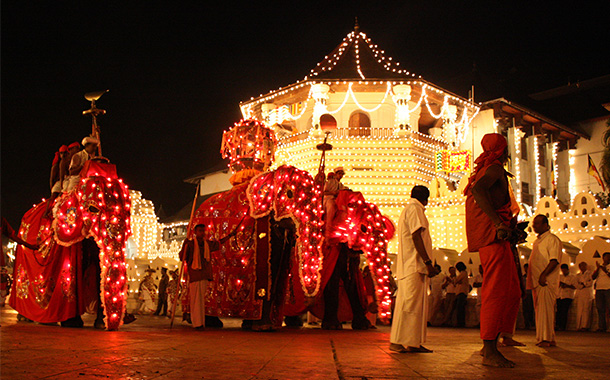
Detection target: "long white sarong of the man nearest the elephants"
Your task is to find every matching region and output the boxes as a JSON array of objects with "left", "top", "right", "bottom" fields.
[{"left": 390, "top": 273, "right": 430, "bottom": 347}]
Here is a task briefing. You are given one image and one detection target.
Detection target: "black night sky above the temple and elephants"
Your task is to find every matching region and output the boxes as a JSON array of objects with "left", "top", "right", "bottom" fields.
[{"left": 1, "top": 0, "right": 610, "bottom": 227}]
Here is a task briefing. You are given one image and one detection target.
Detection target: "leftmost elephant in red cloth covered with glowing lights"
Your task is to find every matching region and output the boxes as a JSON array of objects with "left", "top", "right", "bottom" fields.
[{"left": 10, "top": 161, "right": 131, "bottom": 330}]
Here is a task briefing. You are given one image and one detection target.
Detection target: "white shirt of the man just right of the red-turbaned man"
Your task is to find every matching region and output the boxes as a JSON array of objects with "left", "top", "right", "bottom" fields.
[{"left": 528, "top": 231, "right": 563, "bottom": 289}]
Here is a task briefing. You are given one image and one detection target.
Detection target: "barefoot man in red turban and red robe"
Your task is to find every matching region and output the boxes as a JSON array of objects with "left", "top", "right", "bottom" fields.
[{"left": 464, "top": 133, "right": 521, "bottom": 367}]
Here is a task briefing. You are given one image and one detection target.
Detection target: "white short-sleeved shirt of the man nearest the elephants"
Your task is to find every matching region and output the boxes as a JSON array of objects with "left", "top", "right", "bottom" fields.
[{"left": 396, "top": 198, "right": 434, "bottom": 280}]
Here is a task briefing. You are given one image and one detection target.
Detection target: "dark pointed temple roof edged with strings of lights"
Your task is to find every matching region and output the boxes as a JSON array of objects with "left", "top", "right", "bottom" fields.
[{"left": 305, "top": 24, "right": 421, "bottom": 80}]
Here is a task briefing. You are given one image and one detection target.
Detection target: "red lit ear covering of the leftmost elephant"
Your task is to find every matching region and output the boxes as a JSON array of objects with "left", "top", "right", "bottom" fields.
[{"left": 53, "top": 192, "right": 85, "bottom": 247}]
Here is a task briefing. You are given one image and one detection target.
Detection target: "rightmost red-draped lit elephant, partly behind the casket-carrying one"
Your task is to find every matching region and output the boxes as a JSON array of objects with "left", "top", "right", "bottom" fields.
[{"left": 285, "top": 190, "right": 394, "bottom": 330}]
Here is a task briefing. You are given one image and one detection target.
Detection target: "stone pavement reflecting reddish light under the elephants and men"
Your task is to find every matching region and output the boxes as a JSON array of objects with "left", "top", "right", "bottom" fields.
[{"left": 0, "top": 306, "right": 610, "bottom": 380}]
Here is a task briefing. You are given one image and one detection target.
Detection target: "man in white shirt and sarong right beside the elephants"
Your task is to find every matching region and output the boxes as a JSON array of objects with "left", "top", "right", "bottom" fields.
[{"left": 390, "top": 186, "right": 438, "bottom": 352}]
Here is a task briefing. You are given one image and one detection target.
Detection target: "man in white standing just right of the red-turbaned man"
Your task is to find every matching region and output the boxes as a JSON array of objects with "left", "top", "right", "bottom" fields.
[{"left": 527, "top": 215, "right": 563, "bottom": 347}]
